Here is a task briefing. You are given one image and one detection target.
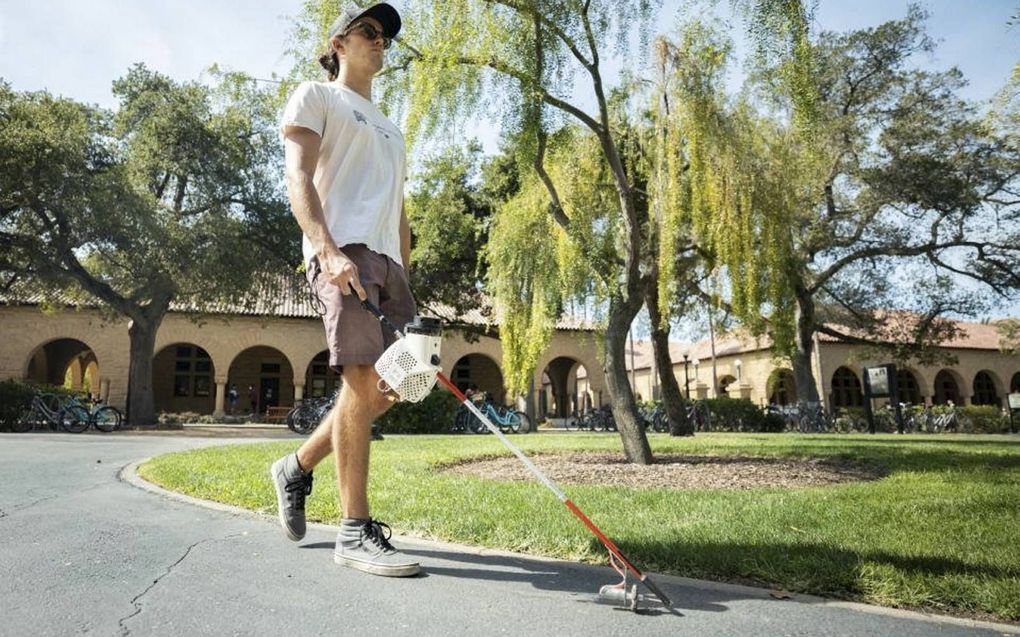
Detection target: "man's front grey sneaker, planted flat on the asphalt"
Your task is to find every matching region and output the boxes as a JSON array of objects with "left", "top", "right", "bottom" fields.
[{"left": 333, "top": 519, "right": 421, "bottom": 577}]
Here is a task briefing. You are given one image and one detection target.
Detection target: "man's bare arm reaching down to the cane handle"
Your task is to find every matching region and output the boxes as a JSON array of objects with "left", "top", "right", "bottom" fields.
[{"left": 284, "top": 126, "right": 365, "bottom": 299}]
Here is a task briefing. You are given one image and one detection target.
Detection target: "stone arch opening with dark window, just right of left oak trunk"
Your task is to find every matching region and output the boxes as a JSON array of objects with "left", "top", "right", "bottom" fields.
[{"left": 152, "top": 341, "right": 216, "bottom": 414}]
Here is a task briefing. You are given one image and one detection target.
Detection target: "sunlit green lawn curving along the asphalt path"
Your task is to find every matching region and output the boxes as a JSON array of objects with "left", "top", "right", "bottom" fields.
[{"left": 140, "top": 433, "right": 1020, "bottom": 621}]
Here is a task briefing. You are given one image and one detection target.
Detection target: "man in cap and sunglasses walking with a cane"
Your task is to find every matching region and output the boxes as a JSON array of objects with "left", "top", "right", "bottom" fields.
[{"left": 270, "top": 3, "right": 420, "bottom": 576}]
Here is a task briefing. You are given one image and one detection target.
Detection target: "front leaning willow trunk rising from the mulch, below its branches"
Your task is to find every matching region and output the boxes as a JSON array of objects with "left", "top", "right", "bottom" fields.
[{"left": 604, "top": 293, "right": 654, "bottom": 465}]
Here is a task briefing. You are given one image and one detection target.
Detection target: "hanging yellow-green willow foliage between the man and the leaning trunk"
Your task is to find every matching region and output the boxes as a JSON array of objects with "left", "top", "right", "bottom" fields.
[{"left": 485, "top": 127, "right": 622, "bottom": 394}]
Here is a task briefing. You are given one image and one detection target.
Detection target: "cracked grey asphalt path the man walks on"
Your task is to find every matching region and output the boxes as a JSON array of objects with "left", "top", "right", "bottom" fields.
[{"left": 0, "top": 433, "right": 1020, "bottom": 637}]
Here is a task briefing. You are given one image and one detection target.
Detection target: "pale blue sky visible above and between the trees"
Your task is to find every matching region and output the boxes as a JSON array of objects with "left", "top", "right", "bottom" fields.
[{"left": 0, "top": 0, "right": 1020, "bottom": 328}]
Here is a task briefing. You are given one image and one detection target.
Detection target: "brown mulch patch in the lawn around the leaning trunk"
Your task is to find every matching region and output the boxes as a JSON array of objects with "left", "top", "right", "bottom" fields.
[{"left": 444, "top": 453, "right": 884, "bottom": 489}]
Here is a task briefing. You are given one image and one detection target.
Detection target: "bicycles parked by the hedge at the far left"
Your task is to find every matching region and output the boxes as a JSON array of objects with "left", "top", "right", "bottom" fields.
[{"left": 11, "top": 392, "right": 123, "bottom": 433}]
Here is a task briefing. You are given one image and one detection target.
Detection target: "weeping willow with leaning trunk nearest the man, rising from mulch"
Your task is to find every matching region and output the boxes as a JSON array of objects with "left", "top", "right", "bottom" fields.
[{"left": 285, "top": 0, "right": 820, "bottom": 464}]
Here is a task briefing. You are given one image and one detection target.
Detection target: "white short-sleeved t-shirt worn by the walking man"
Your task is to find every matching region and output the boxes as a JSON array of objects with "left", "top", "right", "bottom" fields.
[{"left": 282, "top": 82, "right": 407, "bottom": 265}]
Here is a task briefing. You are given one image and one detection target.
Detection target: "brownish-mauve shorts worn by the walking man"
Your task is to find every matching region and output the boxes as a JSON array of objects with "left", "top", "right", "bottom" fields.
[{"left": 308, "top": 244, "right": 417, "bottom": 372}]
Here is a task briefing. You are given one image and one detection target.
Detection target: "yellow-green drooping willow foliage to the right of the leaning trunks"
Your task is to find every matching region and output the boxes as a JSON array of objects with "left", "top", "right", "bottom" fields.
[{"left": 653, "top": 21, "right": 817, "bottom": 353}]
